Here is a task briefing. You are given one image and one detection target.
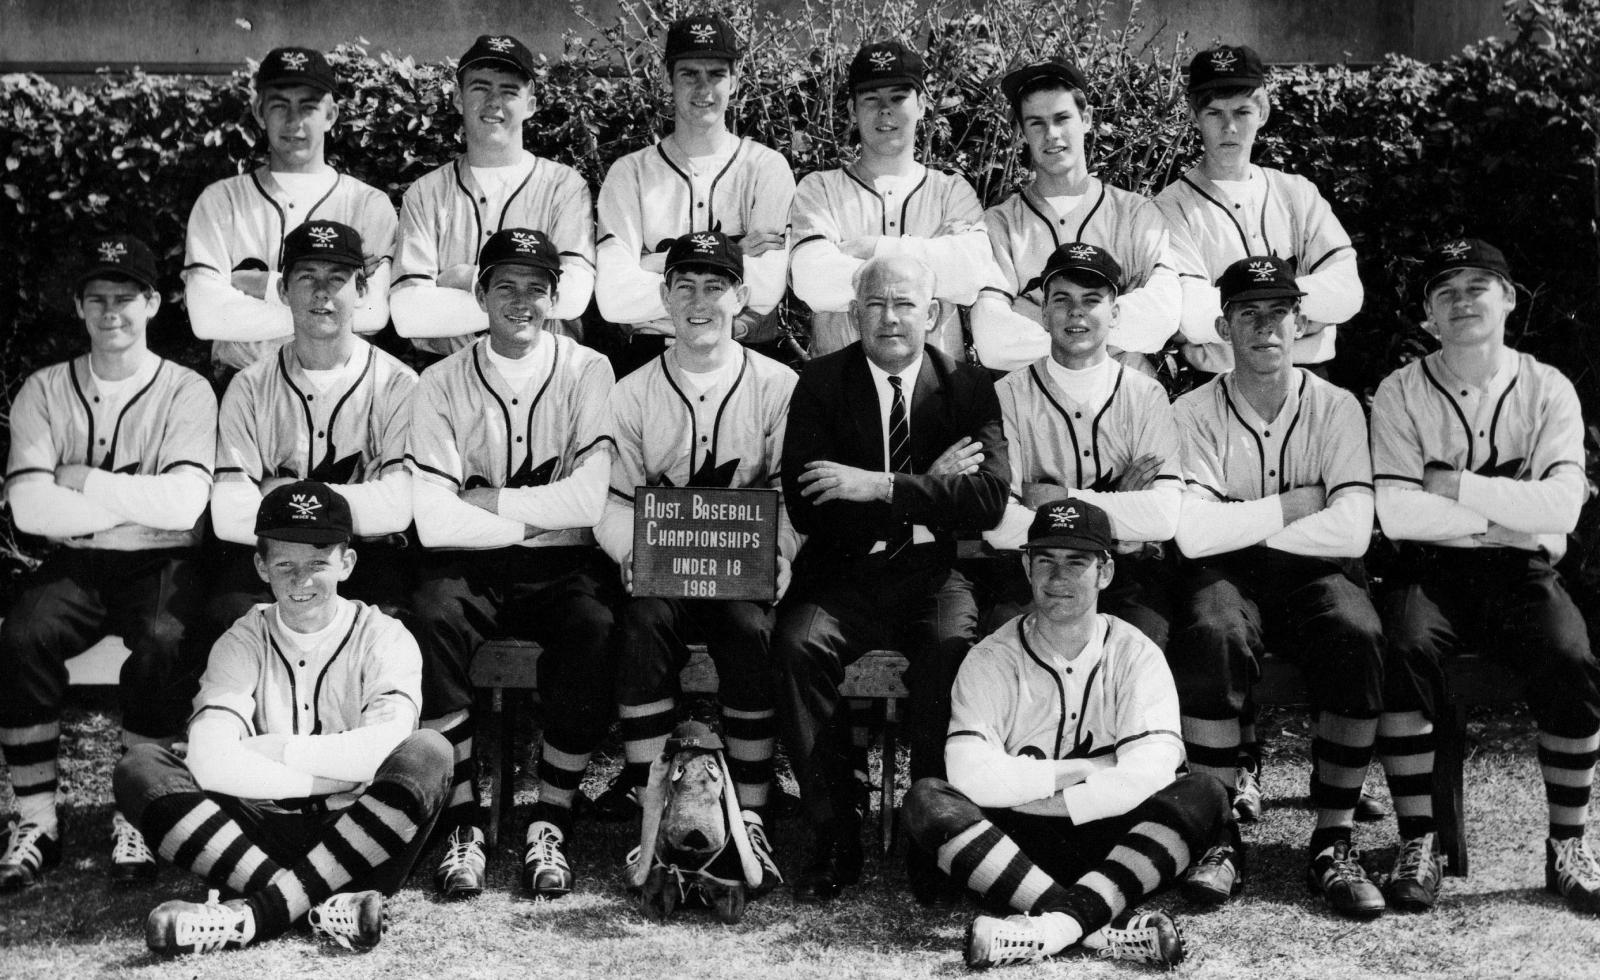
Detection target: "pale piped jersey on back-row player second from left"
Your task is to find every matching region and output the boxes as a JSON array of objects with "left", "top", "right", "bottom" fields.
[{"left": 390, "top": 154, "right": 595, "bottom": 354}]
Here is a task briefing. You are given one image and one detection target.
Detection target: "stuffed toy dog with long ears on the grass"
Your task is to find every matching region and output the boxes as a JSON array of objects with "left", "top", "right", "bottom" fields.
[{"left": 629, "top": 721, "right": 763, "bottom": 922}]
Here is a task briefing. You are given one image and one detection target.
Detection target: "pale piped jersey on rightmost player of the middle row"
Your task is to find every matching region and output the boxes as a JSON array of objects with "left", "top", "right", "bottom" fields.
[{"left": 1373, "top": 349, "right": 1587, "bottom": 560}]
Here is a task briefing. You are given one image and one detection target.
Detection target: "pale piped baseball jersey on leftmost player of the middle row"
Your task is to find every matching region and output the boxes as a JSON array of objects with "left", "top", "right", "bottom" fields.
[{"left": 6, "top": 354, "right": 216, "bottom": 551}]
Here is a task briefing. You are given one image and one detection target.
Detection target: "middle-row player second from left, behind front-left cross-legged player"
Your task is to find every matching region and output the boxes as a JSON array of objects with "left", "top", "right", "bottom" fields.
[{"left": 210, "top": 219, "right": 416, "bottom": 633}]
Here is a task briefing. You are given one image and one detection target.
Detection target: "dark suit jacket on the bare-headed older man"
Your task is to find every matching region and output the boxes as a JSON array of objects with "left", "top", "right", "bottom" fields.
[{"left": 784, "top": 341, "right": 1011, "bottom": 570}]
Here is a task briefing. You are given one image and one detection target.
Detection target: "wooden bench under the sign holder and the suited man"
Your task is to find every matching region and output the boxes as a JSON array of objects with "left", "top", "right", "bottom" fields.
[{"left": 469, "top": 641, "right": 907, "bottom": 853}]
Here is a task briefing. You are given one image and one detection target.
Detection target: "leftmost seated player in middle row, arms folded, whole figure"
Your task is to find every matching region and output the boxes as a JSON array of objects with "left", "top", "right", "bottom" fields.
[{"left": 0, "top": 235, "right": 216, "bottom": 892}]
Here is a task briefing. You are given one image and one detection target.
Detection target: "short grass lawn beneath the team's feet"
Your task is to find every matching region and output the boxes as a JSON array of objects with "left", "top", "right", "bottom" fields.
[{"left": 0, "top": 695, "right": 1600, "bottom": 980}]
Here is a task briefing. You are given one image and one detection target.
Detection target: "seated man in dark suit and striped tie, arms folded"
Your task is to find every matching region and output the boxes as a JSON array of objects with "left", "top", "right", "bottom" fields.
[{"left": 773, "top": 256, "right": 1010, "bottom": 902}]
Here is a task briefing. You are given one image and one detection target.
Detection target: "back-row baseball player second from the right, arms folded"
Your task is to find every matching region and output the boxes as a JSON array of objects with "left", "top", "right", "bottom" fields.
[{"left": 973, "top": 59, "right": 1182, "bottom": 372}]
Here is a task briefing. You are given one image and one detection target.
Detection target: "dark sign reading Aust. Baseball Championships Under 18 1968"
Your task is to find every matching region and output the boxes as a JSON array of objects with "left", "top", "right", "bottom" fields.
[{"left": 634, "top": 487, "right": 782, "bottom": 602}]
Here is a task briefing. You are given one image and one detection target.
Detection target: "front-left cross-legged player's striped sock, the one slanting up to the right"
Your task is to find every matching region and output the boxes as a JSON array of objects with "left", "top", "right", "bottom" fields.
[{"left": 245, "top": 780, "right": 427, "bottom": 940}]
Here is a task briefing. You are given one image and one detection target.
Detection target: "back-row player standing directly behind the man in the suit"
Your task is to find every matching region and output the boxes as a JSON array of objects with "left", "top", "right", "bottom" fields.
[{"left": 790, "top": 40, "right": 1000, "bottom": 360}]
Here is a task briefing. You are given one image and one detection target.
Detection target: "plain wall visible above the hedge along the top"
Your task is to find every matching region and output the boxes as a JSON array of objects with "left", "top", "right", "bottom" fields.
[{"left": 0, "top": 0, "right": 1504, "bottom": 75}]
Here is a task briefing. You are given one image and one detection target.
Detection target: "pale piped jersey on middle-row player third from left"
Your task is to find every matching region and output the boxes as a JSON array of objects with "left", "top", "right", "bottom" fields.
[{"left": 406, "top": 335, "right": 614, "bottom": 546}]
